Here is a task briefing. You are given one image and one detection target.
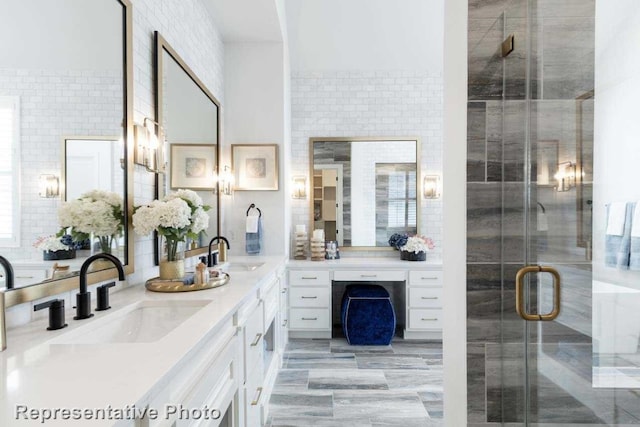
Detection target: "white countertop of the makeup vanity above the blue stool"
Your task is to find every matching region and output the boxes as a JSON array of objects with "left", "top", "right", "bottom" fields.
[{"left": 287, "top": 253, "right": 442, "bottom": 270}]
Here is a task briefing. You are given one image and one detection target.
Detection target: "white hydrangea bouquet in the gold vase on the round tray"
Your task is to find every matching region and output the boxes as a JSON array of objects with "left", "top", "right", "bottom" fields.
[{"left": 133, "top": 190, "right": 210, "bottom": 261}]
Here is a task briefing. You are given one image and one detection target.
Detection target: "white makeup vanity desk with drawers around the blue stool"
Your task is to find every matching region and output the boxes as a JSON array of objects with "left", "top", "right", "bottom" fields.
[{"left": 287, "top": 257, "right": 443, "bottom": 340}]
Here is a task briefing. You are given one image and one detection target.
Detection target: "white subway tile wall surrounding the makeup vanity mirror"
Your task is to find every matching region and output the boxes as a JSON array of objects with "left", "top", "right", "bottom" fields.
[{"left": 291, "top": 71, "right": 443, "bottom": 259}]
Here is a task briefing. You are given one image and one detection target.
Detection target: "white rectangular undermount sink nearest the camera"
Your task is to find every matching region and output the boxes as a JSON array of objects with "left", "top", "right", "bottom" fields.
[{"left": 51, "top": 300, "right": 211, "bottom": 344}]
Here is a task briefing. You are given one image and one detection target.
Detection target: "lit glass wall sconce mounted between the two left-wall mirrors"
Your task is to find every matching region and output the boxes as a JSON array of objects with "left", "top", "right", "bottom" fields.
[{"left": 133, "top": 117, "right": 166, "bottom": 173}]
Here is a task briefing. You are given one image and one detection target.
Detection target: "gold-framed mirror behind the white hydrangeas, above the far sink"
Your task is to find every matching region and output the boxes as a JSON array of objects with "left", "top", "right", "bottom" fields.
[{"left": 155, "top": 31, "right": 220, "bottom": 264}]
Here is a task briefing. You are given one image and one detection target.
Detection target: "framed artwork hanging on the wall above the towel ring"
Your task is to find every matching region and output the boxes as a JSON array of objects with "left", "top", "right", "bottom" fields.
[{"left": 231, "top": 144, "right": 278, "bottom": 191}]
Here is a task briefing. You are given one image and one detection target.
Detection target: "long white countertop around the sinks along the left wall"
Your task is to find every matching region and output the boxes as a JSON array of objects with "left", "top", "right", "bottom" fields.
[{"left": 0, "top": 256, "right": 285, "bottom": 426}]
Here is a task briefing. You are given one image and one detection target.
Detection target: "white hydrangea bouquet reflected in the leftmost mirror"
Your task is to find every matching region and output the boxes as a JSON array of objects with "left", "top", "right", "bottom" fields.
[{"left": 58, "top": 190, "right": 124, "bottom": 253}]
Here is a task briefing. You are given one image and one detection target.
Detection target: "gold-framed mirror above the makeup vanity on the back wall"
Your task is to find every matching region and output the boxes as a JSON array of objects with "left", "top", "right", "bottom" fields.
[{"left": 309, "top": 137, "right": 421, "bottom": 250}]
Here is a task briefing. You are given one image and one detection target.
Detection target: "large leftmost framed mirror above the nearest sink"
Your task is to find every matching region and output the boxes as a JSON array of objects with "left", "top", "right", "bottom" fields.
[{"left": 0, "top": 0, "right": 134, "bottom": 289}]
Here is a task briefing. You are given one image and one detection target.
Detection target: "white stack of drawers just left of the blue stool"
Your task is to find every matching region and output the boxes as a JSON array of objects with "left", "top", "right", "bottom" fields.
[{"left": 289, "top": 270, "right": 331, "bottom": 338}]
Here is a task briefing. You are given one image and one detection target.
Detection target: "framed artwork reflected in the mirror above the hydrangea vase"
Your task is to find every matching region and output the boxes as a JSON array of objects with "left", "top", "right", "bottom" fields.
[{"left": 170, "top": 144, "right": 217, "bottom": 190}]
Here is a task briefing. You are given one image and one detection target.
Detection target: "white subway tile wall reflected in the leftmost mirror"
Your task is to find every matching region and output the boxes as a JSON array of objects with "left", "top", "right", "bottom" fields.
[{"left": 0, "top": 68, "right": 123, "bottom": 260}]
